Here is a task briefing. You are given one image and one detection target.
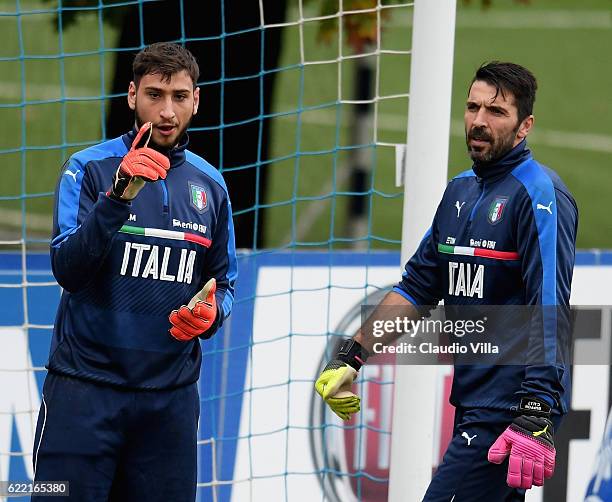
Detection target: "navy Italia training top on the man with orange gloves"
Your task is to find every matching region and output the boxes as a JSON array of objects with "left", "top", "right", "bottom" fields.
[{"left": 47, "top": 130, "right": 237, "bottom": 389}]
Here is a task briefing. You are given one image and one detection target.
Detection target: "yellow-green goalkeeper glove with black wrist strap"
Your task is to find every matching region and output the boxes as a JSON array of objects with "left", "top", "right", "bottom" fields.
[{"left": 315, "top": 339, "right": 369, "bottom": 420}]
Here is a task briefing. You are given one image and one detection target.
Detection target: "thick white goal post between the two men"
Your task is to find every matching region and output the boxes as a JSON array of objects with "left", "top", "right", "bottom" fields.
[{"left": 389, "top": 0, "right": 456, "bottom": 502}]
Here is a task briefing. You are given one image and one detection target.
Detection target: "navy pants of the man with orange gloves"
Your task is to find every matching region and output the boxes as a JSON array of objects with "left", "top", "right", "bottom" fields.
[{"left": 32, "top": 373, "right": 200, "bottom": 502}]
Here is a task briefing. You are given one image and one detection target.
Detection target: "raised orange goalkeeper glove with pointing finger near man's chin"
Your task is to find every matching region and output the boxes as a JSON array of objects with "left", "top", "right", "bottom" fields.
[{"left": 107, "top": 122, "right": 170, "bottom": 201}]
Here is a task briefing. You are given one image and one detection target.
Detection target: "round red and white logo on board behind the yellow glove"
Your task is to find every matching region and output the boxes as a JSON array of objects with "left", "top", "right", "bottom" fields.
[{"left": 310, "top": 290, "right": 453, "bottom": 502}]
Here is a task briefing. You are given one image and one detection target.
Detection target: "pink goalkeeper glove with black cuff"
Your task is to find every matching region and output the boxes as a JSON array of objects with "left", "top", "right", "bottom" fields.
[{"left": 488, "top": 398, "right": 556, "bottom": 489}]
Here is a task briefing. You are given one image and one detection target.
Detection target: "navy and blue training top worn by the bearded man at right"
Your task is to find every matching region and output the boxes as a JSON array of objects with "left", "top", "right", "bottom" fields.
[{"left": 394, "top": 140, "right": 578, "bottom": 413}]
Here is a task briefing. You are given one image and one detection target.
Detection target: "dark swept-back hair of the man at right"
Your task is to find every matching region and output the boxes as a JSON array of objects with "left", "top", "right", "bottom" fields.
[{"left": 470, "top": 61, "right": 538, "bottom": 123}]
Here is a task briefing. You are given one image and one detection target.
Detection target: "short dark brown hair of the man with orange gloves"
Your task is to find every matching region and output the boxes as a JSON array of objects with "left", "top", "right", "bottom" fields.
[{"left": 132, "top": 42, "right": 200, "bottom": 88}]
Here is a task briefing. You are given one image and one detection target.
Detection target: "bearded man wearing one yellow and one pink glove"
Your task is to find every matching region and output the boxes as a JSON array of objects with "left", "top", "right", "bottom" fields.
[{"left": 316, "top": 62, "right": 578, "bottom": 502}]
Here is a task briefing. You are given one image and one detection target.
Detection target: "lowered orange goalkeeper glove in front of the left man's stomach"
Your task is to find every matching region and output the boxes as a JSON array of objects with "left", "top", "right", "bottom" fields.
[{"left": 169, "top": 279, "right": 218, "bottom": 342}]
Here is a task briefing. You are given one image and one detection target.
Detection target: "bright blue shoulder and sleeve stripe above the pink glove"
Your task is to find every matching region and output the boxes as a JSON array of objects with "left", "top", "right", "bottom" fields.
[{"left": 512, "top": 159, "right": 557, "bottom": 364}]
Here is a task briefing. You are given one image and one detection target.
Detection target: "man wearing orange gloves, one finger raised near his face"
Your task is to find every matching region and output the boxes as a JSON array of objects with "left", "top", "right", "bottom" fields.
[{"left": 33, "top": 43, "right": 237, "bottom": 502}]
